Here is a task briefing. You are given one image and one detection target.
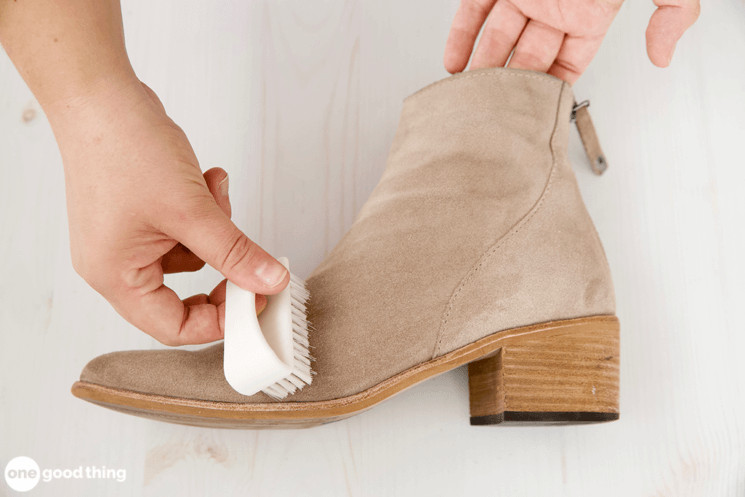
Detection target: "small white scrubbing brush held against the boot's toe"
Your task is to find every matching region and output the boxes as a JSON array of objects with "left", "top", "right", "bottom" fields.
[{"left": 223, "top": 257, "right": 313, "bottom": 399}]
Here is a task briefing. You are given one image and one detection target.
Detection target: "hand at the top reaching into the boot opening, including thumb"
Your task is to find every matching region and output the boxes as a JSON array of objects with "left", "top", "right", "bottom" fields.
[{"left": 444, "top": 0, "right": 700, "bottom": 83}]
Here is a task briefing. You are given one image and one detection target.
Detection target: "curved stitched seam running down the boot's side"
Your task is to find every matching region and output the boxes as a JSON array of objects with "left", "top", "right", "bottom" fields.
[{"left": 432, "top": 83, "right": 571, "bottom": 359}]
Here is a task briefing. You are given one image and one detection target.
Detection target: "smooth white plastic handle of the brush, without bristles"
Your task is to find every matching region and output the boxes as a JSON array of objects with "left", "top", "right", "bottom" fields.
[{"left": 223, "top": 258, "right": 293, "bottom": 395}]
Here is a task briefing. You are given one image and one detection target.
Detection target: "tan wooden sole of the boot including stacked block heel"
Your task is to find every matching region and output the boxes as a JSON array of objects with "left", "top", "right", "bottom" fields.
[{"left": 72, "top": 315, "right": 619, "bottom": 429}]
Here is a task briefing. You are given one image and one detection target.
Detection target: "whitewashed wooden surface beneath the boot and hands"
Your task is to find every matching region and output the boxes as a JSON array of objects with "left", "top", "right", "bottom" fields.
[{"left": 0, "top": 0, "right": 745, "bottom": 497}]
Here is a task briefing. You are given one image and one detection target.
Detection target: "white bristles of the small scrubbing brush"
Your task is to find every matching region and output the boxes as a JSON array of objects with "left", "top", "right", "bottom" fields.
[{"left": 263, "top": 273, "right": 314, "bottom": 399}]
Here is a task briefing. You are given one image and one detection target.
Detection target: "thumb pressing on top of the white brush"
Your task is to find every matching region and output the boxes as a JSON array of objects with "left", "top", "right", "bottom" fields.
[{"left": 168, "top": 192, "right": 290, "bottom": 295}]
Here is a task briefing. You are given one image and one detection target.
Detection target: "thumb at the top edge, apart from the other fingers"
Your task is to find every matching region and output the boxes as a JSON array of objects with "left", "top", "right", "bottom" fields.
[{"left": 647, "top": 0, "right": 701, "bottom": 67}]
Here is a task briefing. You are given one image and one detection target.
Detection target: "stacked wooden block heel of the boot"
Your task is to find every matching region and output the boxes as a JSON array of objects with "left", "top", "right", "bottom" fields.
[{"left": 468, "top": 319, "right": 619, "bottom": 425}]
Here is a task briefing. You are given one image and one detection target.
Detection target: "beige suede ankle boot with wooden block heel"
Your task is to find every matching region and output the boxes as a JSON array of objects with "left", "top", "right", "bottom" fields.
[{"left": 72, "top": 69, "right": 619, "bottom": 428}]
